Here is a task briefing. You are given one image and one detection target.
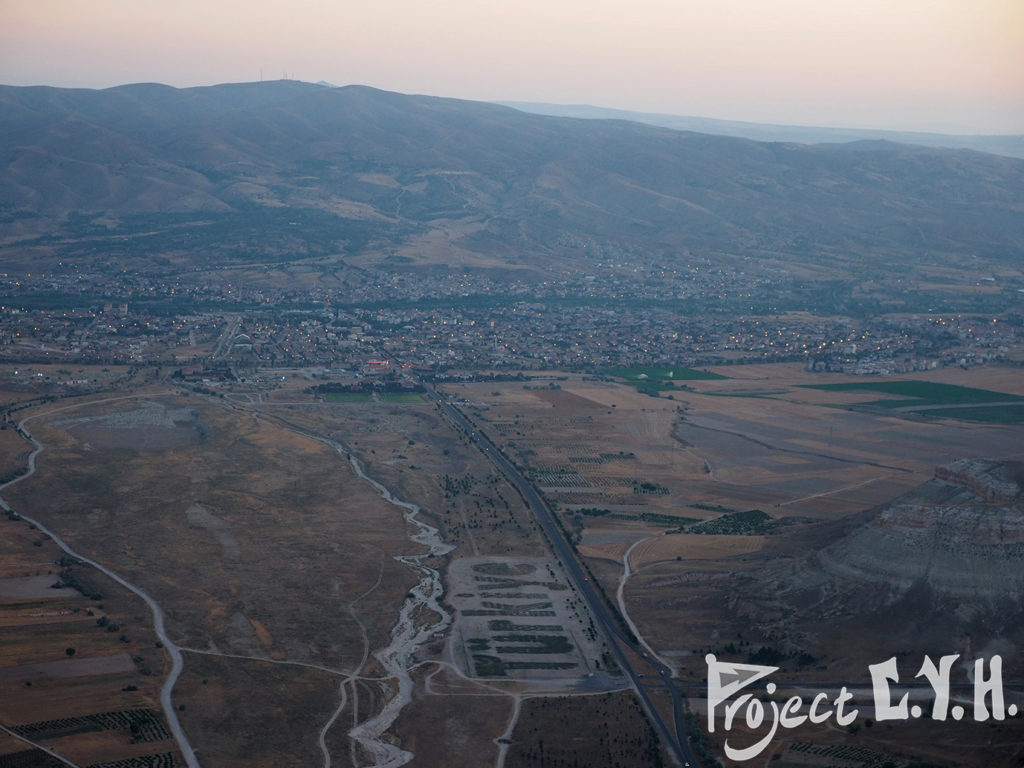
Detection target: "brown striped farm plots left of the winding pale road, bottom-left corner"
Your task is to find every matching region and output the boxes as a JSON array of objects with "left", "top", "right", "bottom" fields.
[{"left": 0, "top": 516, "right": 180, "bottom": 768}]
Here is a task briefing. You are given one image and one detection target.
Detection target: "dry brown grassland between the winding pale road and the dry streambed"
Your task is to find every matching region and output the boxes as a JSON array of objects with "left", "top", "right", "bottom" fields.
[{"left": 11, "top": 398, "right": 412, "bottom": 667}]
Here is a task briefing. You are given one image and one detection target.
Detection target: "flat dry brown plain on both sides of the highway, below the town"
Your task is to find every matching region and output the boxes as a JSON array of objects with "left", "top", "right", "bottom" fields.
[{"left": 0, "top": 365, "right": 1024, "bottom": 768}]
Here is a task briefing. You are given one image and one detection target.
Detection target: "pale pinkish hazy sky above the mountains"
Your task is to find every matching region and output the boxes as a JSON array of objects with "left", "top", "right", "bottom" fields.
[{"left": 0, "top": 0, "right": 1024, "bottom": 133}]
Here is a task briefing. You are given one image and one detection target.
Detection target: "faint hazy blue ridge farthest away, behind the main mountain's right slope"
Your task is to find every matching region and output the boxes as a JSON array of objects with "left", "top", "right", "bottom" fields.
[{"left": 498, "top": 101, "right": 1024, "bottom": 158}]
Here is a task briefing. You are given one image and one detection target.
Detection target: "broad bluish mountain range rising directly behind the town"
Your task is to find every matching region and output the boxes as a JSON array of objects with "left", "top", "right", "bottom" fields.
[{"left": 0, "top": 81, "right": 1024, "bottom": 279}]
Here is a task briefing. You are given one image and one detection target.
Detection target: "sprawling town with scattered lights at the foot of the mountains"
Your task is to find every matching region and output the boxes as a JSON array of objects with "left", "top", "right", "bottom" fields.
[{"left": 0, "top": 264, "right": 1024, "bottom": 375}]
